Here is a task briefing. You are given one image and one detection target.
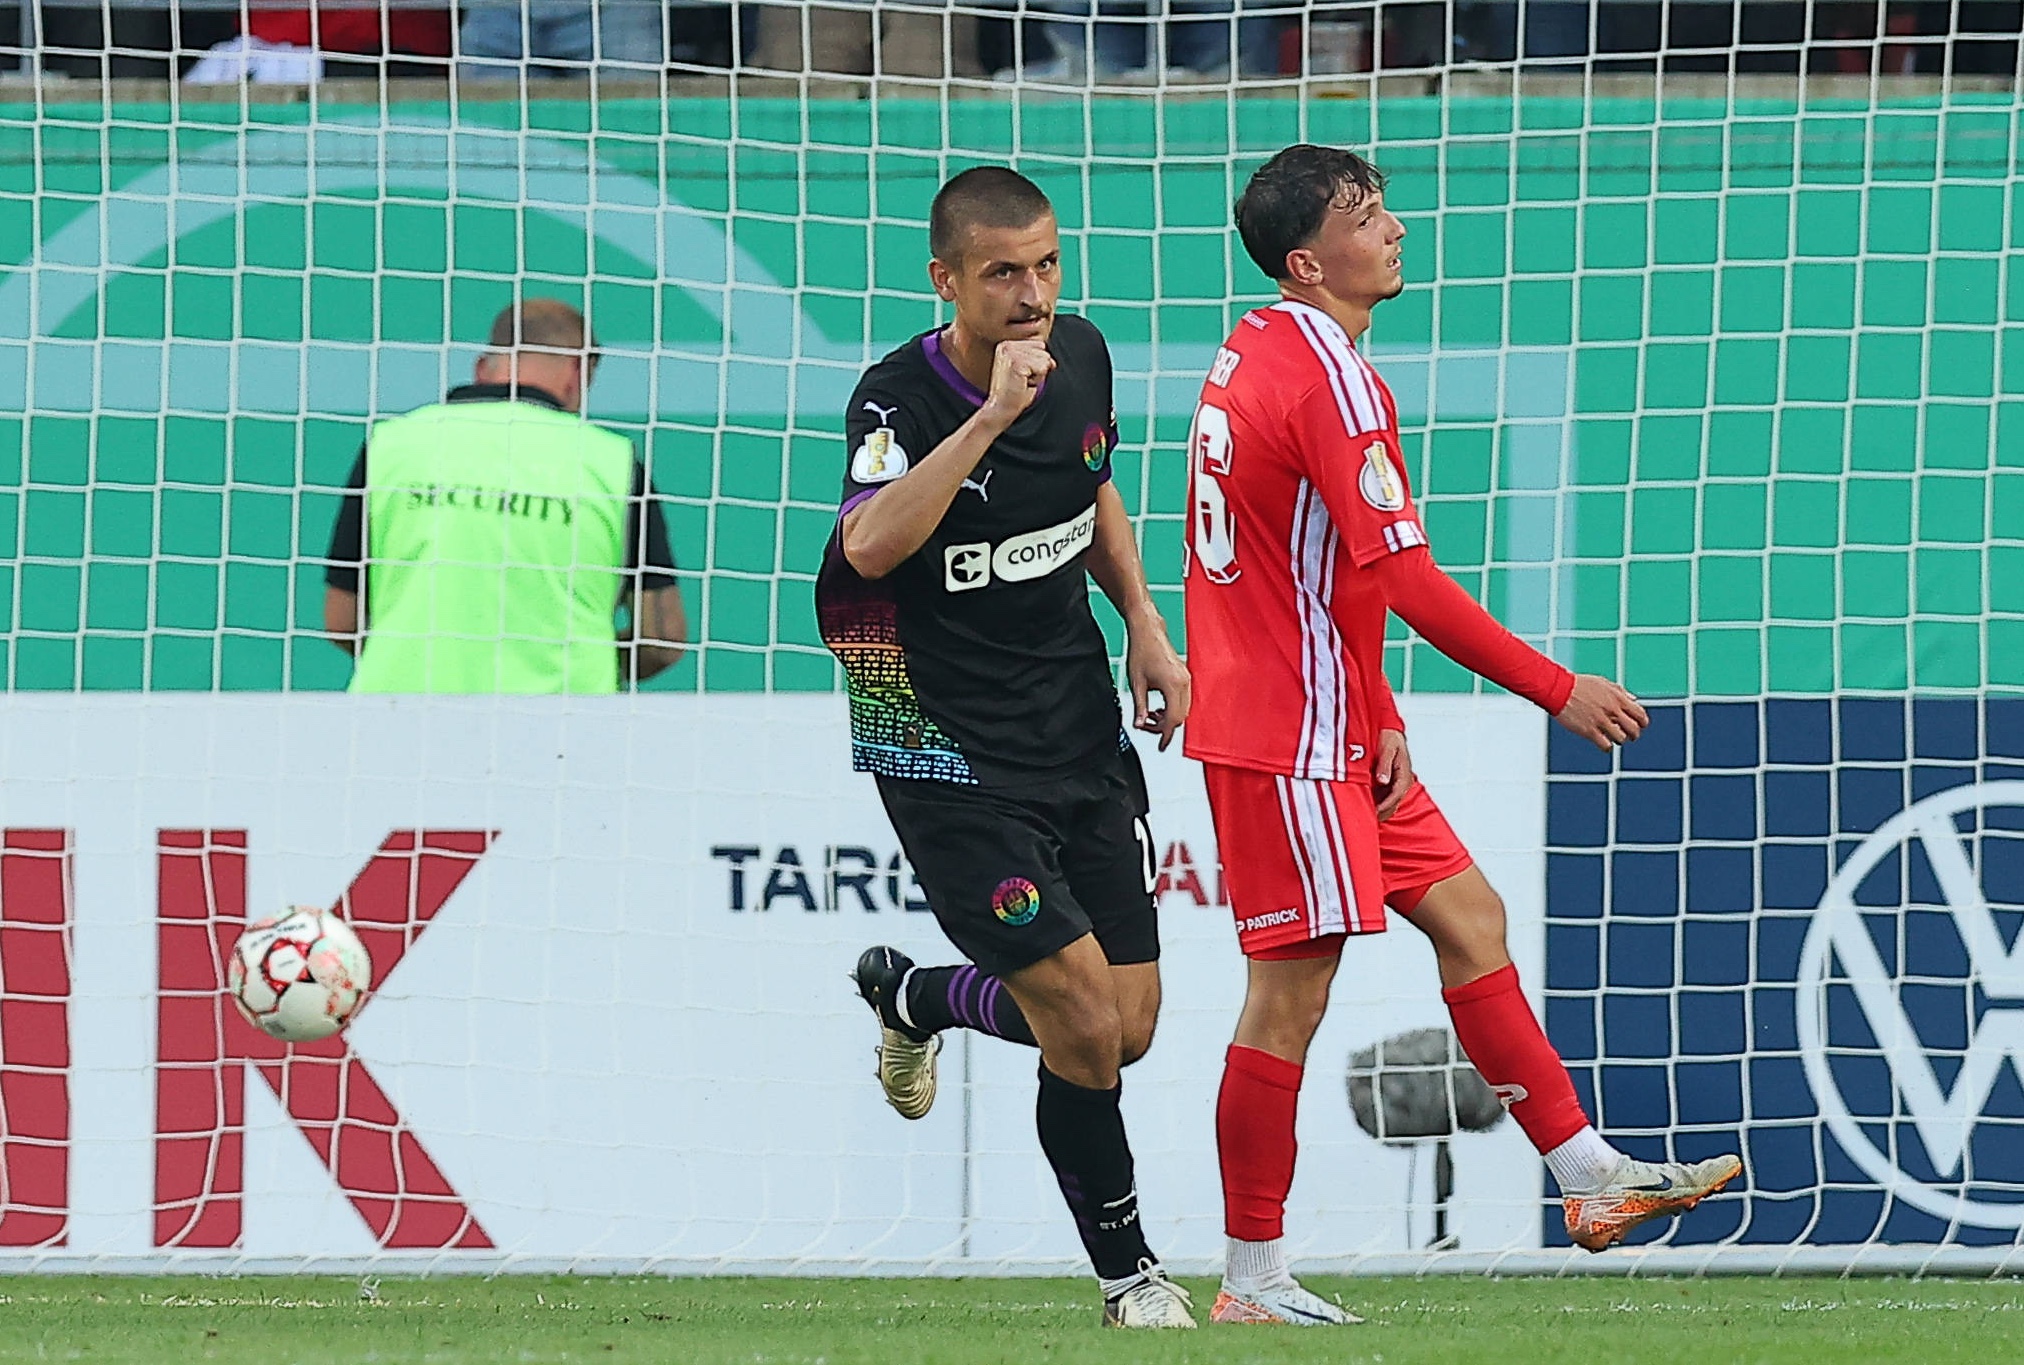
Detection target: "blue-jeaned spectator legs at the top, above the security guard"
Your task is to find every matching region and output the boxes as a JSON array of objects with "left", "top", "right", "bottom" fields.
[{"left": 457, "top": 0, "right": 668, "bottom": 81}]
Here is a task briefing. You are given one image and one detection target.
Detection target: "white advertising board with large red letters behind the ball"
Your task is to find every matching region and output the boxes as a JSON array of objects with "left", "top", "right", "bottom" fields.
[{"left": 0, "top": 695, "right": 1544, "bottom": 1272}]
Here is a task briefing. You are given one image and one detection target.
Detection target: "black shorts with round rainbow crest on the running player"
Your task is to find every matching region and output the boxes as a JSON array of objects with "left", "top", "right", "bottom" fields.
[{"left": 878, "top": 747, "right": 1160, "bottom": 976}]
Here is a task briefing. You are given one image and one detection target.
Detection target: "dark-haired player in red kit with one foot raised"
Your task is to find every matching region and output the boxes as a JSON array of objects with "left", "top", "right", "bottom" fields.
[{"left": 1186, "top": 146, "right": 1741, "bottom": 1324}]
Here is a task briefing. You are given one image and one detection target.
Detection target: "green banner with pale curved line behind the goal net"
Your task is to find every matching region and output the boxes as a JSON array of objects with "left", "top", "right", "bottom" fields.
[{"left": 0, "top": 95, "right": 2024, "bottom": 695}]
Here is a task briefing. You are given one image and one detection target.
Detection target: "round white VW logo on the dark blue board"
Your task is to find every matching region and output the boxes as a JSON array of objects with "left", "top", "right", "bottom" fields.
[{"left": 1797, "top": 782, "right": 2024, "bottom": 1227}]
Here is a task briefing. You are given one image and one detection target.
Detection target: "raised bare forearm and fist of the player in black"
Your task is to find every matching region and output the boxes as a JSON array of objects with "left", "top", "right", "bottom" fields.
[{"left": 844, "top": 338, "right": 1055, "bottom": 579}]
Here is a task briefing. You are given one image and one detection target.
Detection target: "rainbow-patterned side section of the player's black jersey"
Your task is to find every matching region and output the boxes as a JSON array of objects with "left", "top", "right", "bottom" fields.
[{"left": 816, "top": 541, "right": 978, "bottom": 784}]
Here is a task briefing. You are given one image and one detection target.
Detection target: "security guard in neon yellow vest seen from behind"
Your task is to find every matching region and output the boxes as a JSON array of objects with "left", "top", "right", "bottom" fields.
[{"left": 324, "top": 298, "right": 688, "bottom": 693}]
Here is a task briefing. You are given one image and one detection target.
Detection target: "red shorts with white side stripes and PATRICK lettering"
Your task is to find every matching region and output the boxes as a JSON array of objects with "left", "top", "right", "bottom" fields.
[{"left": 1202, "top": 764, "right": 1473, "bottom": 956}]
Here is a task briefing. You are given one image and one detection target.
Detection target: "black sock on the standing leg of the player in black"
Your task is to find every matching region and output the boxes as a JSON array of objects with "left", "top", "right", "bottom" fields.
[{"left": 1038, "top": 1061, "right": 1154, "bottom": 1280}]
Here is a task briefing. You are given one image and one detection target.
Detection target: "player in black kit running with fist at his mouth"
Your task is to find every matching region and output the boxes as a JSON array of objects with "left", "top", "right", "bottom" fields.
[{"left": 816, "top": 166, "right": 1194, "bottom": 1327}]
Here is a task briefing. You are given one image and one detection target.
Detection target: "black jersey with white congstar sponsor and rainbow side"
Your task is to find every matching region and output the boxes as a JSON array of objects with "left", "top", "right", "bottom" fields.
[{"left": 816, "top": 314, "right": 1121, "bottom": 786}]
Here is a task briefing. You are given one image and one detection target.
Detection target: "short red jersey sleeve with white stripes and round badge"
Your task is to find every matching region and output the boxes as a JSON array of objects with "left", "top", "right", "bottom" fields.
[{"left": 1287, "top": 374, "right": 1427, "bottom": 569}]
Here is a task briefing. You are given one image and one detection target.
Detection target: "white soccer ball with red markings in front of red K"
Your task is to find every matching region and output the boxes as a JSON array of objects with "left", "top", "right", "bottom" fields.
[{"left": 225, "top": 905, "right": 372, "bottom": 1043}]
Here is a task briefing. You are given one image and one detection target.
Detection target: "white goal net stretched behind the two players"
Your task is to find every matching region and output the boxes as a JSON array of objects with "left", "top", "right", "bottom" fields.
[{"left": 0, "top": 0, "right": 2024, "bottom": 1272}]
